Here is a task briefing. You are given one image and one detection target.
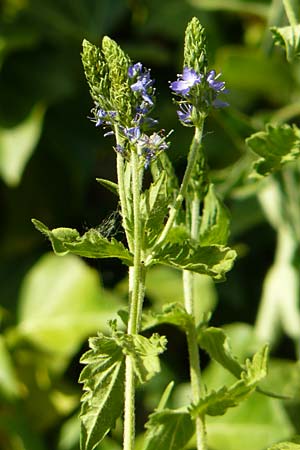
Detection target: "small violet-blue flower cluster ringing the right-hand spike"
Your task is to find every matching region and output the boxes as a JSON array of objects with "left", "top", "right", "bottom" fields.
[{"left": 170, "top": 67, "right": 228, "bottom": 125}]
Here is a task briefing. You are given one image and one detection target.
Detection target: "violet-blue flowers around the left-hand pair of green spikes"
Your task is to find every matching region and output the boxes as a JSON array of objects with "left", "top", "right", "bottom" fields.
[{"left": 92, "top": 62, "right": 169, "bottom": 168}]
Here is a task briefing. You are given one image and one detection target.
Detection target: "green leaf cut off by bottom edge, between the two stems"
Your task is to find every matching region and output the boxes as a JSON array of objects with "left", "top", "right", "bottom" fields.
[{"left": 143, "top": 409, "right": 195, "bottom": 450}]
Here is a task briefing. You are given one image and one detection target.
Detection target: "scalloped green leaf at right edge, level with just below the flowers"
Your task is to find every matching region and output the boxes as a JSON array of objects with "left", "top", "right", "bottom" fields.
[{"left": 246, "top": 124, "right": 300, "bottom": 176}]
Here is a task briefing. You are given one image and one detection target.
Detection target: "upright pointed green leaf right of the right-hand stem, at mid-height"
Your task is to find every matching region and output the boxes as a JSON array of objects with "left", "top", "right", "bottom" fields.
[{"left": 199, "top": 184, "right": 230, "bottom": 245}]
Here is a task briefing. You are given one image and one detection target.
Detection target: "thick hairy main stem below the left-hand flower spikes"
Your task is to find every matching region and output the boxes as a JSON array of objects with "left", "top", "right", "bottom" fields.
[{"left": 123, "top": 151, "right": 145, "bottom": 450}]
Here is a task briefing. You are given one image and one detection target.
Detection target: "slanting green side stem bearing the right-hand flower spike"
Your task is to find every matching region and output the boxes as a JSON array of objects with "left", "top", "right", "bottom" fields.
[{"left": 146, "top": 116, "right": 205, "bottom": 265}]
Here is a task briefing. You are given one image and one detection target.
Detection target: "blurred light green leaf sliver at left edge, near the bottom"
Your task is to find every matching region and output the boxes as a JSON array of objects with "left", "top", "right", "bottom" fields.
[{"left": 0, "top": 335, "right": 21, "bottom": 400}]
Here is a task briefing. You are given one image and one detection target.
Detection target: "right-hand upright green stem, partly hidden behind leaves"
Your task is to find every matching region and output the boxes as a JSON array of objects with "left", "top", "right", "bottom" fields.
[{"left": 183, "top": 194, "right": 207, "bottom": 450}]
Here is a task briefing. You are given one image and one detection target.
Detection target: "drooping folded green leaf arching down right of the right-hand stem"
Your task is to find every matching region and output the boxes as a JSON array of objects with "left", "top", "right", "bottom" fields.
[{"left": 198, "top": 327, "right": 243, "bottom": 378}]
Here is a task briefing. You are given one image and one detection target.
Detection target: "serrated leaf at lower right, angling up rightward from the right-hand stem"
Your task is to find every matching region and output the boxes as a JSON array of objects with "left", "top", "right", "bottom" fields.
[{"left": 191, "top": 346, "right": 268, "bottom": 418}]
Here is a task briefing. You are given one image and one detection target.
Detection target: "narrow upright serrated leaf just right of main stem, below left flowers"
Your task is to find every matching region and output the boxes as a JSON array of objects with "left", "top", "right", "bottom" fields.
[{"left": 141, "top": 172, "right": 169, "bottom": 247}]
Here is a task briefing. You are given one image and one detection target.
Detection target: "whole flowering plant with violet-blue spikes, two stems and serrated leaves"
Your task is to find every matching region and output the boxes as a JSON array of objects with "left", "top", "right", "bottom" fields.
[{"left": 34, "top": 13, "right": 296, "bottom": 450}]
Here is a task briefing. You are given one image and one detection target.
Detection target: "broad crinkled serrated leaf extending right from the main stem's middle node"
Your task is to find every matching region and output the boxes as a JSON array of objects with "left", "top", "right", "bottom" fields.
[{"left": 153, "top": 227, "right": 236, "bottom": 281}]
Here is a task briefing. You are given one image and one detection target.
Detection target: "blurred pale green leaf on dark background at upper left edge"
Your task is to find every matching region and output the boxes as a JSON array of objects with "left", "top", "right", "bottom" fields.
[{"left": 0, "top": 105, "right": 45, "bottom": 186}]
